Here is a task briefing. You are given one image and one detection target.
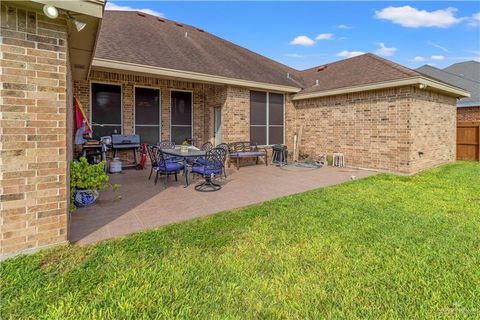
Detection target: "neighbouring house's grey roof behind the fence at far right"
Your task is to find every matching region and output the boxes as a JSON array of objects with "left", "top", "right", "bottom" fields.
[{"left": 417, "top": 61, "right": 480, "bottom": 107}]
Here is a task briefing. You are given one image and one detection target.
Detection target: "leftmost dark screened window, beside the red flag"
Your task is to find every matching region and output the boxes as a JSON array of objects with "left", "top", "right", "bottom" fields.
[{"left": 92, "top": 83, "right": 122, "bottom": 139}]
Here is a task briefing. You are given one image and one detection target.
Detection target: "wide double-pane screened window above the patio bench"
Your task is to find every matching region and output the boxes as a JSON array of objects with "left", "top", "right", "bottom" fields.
[{"left": 250, "top": 91, "right": 284, "bottom": 145}]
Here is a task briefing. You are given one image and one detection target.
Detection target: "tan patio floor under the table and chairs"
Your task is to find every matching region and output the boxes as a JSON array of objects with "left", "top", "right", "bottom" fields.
[{"left": 69, "top": 165, "right": 375, "bottom": 244}]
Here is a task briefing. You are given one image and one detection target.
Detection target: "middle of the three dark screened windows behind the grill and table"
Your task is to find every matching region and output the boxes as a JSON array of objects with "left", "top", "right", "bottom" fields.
[{"left": 135, "top": 88, "right": 161, "bottom": 145}]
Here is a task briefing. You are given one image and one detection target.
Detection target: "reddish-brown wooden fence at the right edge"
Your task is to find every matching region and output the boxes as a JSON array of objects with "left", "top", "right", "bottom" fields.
[{"left": 457, "top": 122, "right": 480, "bottom": 161}]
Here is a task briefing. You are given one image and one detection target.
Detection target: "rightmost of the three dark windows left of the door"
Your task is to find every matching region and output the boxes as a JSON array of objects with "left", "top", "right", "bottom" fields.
[{"left": 170, "top": 91, "right": 192, "bottom": 144}]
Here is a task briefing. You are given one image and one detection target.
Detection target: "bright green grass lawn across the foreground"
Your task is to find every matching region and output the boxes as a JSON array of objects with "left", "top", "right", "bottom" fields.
[{"left": 0, "top": 163, "right": 480, "bottom": 319}]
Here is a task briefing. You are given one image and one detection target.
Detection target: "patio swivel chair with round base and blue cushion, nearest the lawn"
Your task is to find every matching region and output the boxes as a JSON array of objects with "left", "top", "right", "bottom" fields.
[{"left": 192, "top": 148, "right": 226, "bottom": 192}]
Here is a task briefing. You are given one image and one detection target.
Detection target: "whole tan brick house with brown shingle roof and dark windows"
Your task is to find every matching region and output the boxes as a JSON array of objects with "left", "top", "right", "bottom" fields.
[{"left": 0, "top": 0, "right": 468, "bottom": 256}]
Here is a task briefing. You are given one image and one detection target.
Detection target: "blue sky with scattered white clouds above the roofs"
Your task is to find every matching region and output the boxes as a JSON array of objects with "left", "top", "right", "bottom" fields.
[{"left": 107, "top": 1, "right": 480, "bottom": 69}]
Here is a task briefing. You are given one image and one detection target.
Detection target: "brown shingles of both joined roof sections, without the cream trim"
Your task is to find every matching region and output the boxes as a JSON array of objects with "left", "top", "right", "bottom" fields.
[{"left": 95, "top": 11, "right": 454, "bottom": 93}]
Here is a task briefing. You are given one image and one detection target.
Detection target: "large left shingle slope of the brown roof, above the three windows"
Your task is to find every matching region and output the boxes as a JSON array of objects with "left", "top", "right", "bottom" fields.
[{"left": 95, "top": 11, "right": 301, "bottom": 87}]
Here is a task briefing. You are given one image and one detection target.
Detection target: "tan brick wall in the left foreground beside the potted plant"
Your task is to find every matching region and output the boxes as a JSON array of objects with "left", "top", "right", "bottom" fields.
[{"left": 0, "top": 5, "right": 68, "bottom": 256}]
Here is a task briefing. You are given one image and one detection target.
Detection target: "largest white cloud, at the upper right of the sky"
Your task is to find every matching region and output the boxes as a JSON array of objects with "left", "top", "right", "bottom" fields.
[{"left": 375, "top": 6, "right": 462, "bottom": 28}]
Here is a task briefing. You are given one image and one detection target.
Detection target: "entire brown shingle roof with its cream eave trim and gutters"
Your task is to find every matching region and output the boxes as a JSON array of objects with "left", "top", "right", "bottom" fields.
[{"left": 92, "top": 11, "right": 466, "bottom": 99}]
